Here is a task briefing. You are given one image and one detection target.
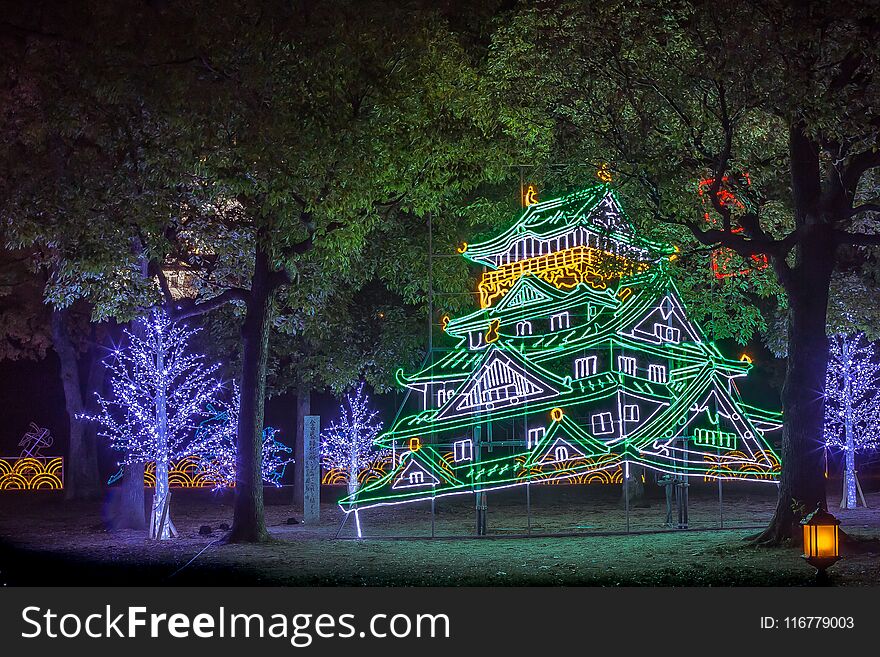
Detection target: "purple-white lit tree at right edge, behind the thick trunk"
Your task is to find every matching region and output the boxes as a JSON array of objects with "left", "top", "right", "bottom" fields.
[{"left": 825, "top": 333, "right": 880, "bottom": 509}]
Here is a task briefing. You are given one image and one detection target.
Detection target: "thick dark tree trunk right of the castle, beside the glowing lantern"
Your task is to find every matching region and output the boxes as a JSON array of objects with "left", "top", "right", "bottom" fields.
[{"left": 757, "top": 224, "right": 834, "bottom": 544}]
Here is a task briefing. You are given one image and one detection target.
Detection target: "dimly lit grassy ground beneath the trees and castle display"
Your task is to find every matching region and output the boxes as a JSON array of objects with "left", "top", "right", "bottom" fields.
[{"left": 0, "top": 484, "right": 880, "bottom": 586}]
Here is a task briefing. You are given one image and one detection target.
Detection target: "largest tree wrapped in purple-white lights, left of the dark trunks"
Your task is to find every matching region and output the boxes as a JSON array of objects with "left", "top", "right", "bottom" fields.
[{"left": 88, "top": 310, "right": 221, "bottom": 540}]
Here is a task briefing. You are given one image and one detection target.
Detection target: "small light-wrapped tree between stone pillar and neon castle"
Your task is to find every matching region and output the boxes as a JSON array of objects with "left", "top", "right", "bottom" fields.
[{"left": 321, "top": 383, "right": 387, "bottom": 495}]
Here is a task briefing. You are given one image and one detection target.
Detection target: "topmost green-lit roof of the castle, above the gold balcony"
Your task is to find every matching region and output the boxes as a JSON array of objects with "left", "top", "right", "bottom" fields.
[{"left": 464, "top": 184, "right": 674, "bottom": 268}]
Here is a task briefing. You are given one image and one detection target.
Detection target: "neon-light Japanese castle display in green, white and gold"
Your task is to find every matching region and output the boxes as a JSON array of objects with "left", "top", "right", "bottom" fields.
[{"left": 340, "top": 184, "right": 781, "bottom": 524}]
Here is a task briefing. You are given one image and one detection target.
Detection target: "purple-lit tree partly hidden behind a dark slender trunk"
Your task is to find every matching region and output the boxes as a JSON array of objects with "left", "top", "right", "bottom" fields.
[{"left": 189, "top": 384, "right": 293, "bottom": 490}]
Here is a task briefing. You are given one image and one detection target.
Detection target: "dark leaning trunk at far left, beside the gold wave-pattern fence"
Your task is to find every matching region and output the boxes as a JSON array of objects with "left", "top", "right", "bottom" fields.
[{"left": 52, "top": 309, "right": 101, "bottom": 500}]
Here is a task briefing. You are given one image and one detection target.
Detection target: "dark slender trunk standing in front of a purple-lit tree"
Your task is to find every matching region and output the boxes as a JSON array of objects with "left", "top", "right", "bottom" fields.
[{"left": 228, "top": 246, "right": 273, "bottom": 543}]
